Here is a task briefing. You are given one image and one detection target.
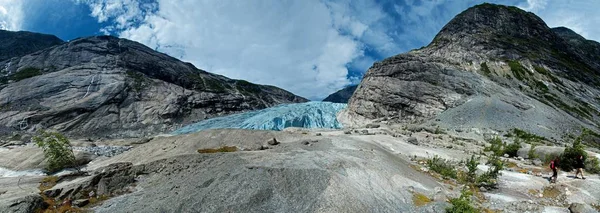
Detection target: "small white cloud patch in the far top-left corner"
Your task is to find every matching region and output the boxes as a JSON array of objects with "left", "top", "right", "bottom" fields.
[{"left": 0, "top": 0, "right": 23, "bottom": 31}]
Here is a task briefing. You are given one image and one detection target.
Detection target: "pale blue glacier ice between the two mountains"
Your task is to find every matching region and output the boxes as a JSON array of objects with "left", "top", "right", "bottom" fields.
[{"left": 173, "top": 102, "right": 346, "bottom": 134}]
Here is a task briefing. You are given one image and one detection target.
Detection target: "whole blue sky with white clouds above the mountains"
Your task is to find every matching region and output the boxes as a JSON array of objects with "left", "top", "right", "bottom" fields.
[{"left": 0, "top": 0, "right": 600, "bottom": 100}]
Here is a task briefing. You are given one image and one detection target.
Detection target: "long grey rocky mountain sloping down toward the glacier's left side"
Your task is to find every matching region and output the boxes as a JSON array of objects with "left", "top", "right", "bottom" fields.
[{"left": 0, "top": 36, "right": 307, "bottom": 138}]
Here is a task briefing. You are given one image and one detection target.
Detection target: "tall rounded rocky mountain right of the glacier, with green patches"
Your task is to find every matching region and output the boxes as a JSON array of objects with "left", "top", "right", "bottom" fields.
[{"left": 338, "top": 3, "right": 600, "bottom": 140}]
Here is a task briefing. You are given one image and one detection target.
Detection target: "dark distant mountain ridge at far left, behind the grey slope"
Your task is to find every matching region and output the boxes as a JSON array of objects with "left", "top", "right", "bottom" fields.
[{"left": 0, "top": 30, "right": 63, "bottom": 61}]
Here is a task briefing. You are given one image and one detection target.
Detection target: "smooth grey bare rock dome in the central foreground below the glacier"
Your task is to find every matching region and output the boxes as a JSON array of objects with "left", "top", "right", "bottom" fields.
[{"left": 84, "top": 130, "right": 447, "bottom": 212}]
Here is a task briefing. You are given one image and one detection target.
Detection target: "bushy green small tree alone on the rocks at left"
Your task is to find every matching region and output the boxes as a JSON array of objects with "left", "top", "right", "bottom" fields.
[{"left": 33, "top": 130, "right": 75, "bottom": 173}]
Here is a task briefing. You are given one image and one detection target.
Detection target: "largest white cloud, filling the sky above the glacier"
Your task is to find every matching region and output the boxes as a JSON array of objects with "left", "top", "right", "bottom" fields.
[{"left": 81, "top": 0, "right": 367, "bottom": 99}]
